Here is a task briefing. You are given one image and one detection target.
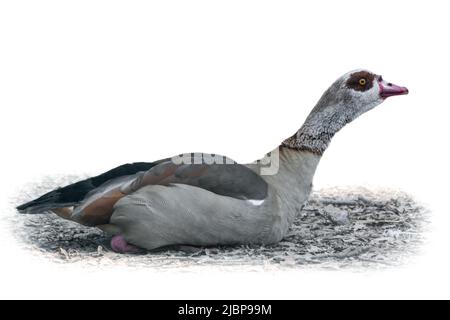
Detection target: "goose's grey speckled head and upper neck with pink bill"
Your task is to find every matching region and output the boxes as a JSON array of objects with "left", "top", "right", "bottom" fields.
[{"left": 282, "top": 69, "right": 408, "bottom": 155}]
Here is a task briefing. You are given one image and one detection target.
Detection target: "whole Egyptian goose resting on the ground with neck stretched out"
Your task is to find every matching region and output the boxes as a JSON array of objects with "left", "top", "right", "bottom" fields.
[{"left": 17, "top": 70, "right": 408, "bottom": 253}]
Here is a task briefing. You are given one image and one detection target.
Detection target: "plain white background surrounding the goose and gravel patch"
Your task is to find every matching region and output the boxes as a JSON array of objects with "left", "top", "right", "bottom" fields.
[{"left": 0, "top": 0, "right": 450, "bottom": 298}]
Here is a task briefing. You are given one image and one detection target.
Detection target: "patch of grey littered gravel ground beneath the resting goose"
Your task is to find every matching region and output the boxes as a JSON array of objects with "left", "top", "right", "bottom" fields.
[{"left": 10, "top": 176, "right": 427, "bottom": 270}]
